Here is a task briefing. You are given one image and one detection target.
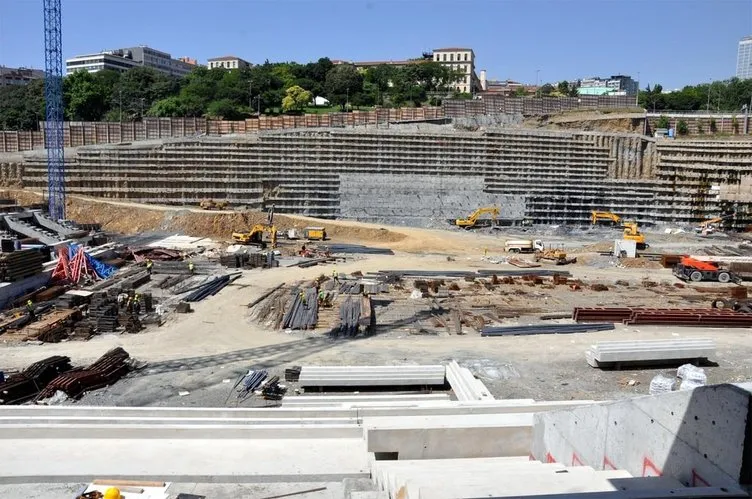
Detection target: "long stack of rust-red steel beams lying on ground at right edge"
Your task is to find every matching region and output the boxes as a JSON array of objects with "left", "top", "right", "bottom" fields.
[{"left": 572, "top": 307, "right": 752, "bottom": 327}]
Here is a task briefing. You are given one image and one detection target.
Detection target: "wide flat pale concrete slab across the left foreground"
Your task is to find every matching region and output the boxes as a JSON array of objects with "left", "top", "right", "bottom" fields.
[{"left": 0, "top": 438, "right": 369, "bottom": 484}]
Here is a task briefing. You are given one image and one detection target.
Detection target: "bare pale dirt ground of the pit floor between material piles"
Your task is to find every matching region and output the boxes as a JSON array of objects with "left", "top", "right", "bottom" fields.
[{"left": 0, "top": 193, "right": 752, "bottom": 406}]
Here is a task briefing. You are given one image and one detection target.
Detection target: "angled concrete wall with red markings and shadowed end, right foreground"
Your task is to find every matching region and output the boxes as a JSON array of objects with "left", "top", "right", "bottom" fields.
[{"left": 532, "top": 385, "right": 752, "bottom": 487}]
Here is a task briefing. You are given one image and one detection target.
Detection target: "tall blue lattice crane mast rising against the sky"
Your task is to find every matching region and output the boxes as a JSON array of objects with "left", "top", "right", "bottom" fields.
[{"left": 42, "top": 0, "right": 65, "bottom": 221}]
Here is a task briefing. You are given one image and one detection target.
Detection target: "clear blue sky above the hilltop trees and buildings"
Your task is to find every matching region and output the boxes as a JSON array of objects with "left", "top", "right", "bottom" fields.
[{"left": 0, "top": 0, "right": 752, "bottom": 89}]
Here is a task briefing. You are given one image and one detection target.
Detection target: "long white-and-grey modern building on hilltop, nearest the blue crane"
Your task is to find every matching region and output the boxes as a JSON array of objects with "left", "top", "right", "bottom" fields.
[{"left": 65, "top": 45, "right": 197, "bottom": 76}]
